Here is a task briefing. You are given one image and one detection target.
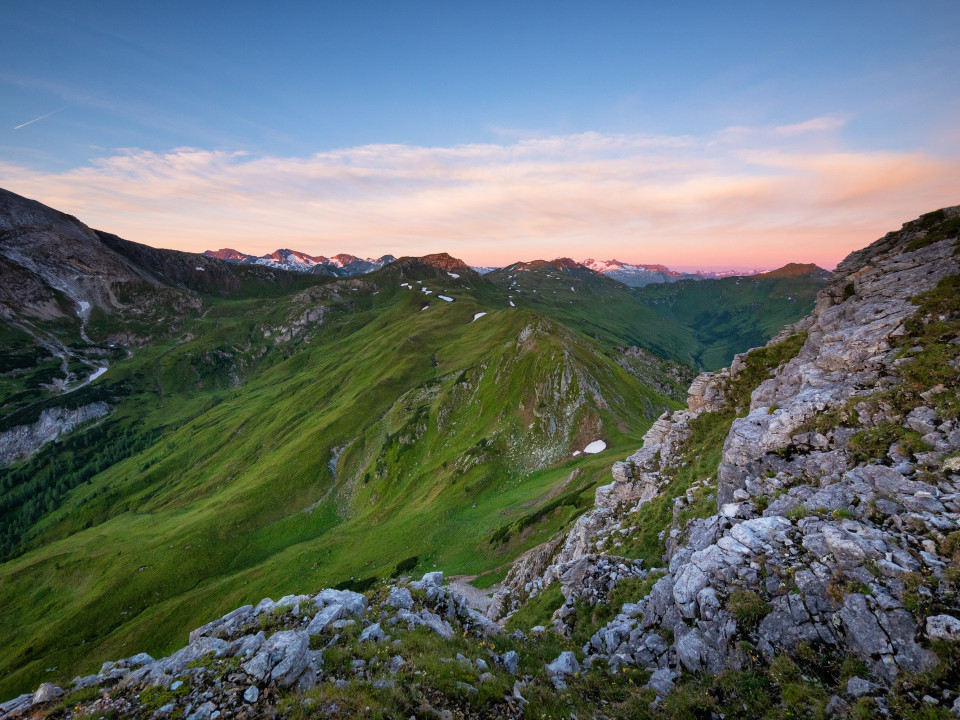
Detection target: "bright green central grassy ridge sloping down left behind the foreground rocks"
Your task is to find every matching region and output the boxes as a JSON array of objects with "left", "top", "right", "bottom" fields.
[{"left": 0, "top": 268, "right": 669, "bottom": 696}]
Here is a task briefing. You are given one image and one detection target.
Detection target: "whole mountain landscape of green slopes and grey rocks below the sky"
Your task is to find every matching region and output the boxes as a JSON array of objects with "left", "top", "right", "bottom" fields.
[{"left": 0, "top": 190, "right": 960, "bottom": 720}]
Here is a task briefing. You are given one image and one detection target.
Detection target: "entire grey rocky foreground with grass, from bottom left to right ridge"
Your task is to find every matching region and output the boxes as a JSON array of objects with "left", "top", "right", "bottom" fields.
[{"left": 0, "top": 207, "right": 960, "bottom": 720}]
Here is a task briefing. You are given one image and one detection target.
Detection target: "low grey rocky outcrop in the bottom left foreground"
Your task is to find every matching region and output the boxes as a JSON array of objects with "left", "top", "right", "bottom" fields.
[{"left": 0, "top": 572, "right": 522, "bottom": 720}]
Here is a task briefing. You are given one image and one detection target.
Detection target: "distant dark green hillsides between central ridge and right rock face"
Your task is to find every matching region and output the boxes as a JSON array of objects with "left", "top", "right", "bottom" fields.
[{"left": 486, "top": 258, "right": 829, "bottom": 370}]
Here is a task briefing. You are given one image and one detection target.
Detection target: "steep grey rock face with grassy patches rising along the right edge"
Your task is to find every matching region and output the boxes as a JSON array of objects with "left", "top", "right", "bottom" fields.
[{"left": 499, "top": 208, "right": 960, "bottom": 697}]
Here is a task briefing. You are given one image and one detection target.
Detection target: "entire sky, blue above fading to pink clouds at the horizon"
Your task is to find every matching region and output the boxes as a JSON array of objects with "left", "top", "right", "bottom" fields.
[{"left": 0, "top": 0, "right": 960, "bottom": 270}]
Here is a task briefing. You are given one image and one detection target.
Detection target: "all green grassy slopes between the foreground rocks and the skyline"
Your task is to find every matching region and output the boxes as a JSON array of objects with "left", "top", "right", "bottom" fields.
[{"left": 0, "top": 258, "right": 824, "bottom": 696}]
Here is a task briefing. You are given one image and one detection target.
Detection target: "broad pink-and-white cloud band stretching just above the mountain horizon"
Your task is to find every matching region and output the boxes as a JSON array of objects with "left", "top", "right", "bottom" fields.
[{"left": 0, "top": 118, "right": 960, "bottom": 267}]
